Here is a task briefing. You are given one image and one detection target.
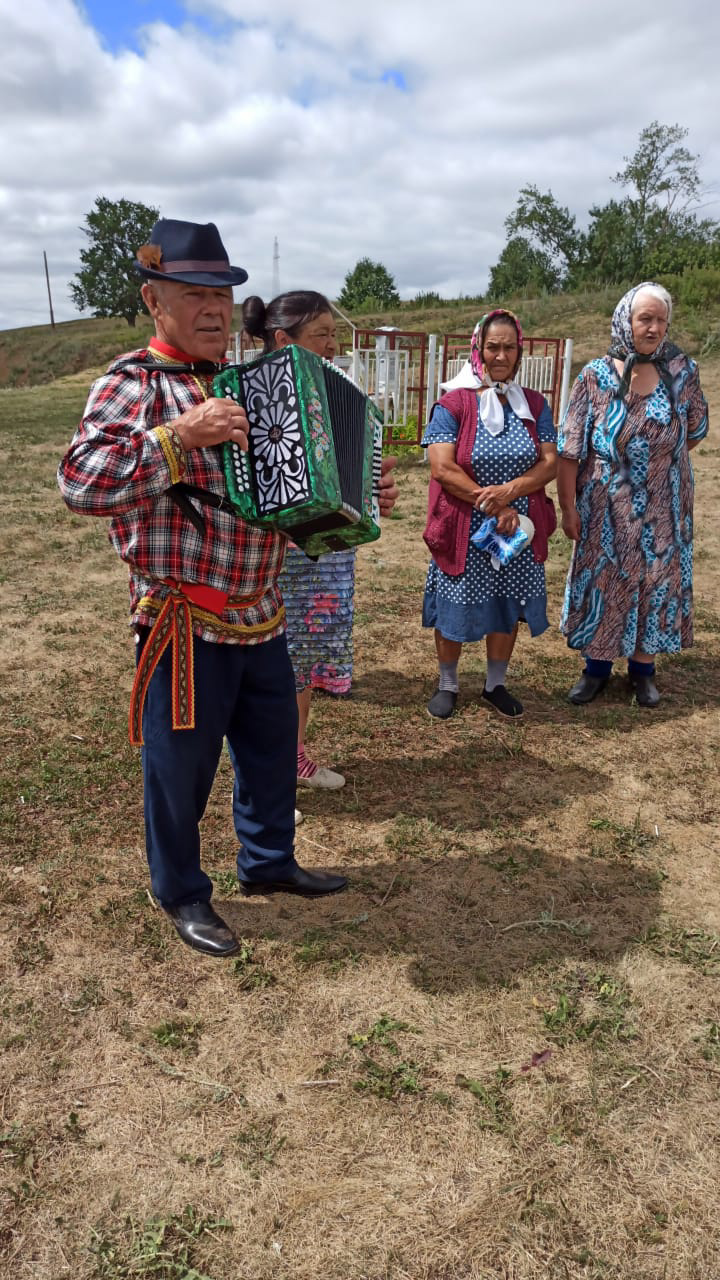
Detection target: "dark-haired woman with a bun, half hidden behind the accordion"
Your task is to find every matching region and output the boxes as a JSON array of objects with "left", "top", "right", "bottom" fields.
[{"left": 242, "top": 289, "right": 397, "bottom": 790}]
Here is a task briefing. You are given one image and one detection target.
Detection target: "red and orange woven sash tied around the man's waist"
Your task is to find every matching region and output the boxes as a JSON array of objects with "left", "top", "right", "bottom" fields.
[{"left": 128, "top": 579, "right": 270, "bottom": 746}]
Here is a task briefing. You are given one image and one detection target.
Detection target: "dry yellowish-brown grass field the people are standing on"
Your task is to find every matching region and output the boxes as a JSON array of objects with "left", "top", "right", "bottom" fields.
[{"left": 0, "top": 358, "right": 720, "bottom": 1280}]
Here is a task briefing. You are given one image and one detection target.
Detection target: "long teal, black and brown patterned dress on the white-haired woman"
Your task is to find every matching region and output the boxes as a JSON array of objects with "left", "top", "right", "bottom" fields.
[{"left": 557, "top": 353, "right": 707, "bottom": 660}]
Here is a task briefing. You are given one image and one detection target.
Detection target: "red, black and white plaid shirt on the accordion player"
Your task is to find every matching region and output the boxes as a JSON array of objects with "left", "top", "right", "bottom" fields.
[{"left": 58, "top": 339, "right": 287, "bottom": 644}]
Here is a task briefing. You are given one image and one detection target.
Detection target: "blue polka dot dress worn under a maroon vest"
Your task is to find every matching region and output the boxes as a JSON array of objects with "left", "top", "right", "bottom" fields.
[{"left": 423, "top": 399, "right": 555, "bottom": 643}]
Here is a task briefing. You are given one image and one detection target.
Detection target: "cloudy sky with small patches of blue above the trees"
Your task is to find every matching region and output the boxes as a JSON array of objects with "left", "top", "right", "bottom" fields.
[{"left": 0, "top": 0, "right": 720, "bottom": 328}]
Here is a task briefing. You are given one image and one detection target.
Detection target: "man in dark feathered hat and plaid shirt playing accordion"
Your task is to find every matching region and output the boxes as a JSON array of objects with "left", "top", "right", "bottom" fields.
[{"left": 58, "top": 219, "right": 363, "bottom": 956}]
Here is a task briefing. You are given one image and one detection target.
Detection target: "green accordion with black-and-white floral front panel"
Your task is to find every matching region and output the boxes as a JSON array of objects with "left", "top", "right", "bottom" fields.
[{"left": 214, "top": 346, "right": 383, "bottom": 556}]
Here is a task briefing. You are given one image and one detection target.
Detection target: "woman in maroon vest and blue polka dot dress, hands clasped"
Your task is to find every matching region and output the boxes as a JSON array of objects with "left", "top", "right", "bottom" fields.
[{"left": 423, "top": 310, "right": 556, "bottom": 719}]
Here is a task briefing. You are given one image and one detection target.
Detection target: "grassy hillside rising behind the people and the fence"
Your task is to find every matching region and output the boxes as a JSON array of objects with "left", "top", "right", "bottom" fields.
[{"left": 0, "top": 281, "right": 720, "bottom": 387}]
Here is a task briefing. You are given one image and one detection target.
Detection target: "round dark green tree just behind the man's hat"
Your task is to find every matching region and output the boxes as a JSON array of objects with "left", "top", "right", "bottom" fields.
[{"left": 70, "top": 196, "right": 158, "bottom": 328}]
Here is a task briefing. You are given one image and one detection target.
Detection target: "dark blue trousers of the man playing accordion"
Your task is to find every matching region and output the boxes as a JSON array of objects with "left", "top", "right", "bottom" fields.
[{"left": 138, "top": 631, "right": 297, "bottom": 906}]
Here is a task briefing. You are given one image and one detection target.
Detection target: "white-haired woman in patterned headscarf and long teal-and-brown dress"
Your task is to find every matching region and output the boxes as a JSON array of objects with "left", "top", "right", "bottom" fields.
[{"left": 557, "top": 280, "right": 707, "bottom": 707}]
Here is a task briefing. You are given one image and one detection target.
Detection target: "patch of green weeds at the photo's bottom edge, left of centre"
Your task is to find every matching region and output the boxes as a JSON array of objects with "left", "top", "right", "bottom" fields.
[{"left": 88, "top": 1204, "right": 233, "bottom": 1280}]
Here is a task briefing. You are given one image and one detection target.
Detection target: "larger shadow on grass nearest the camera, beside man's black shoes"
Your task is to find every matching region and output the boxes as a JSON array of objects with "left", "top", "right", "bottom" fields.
[{"left": 220, "top": 844, "right": 660, "bottom": 993}]
